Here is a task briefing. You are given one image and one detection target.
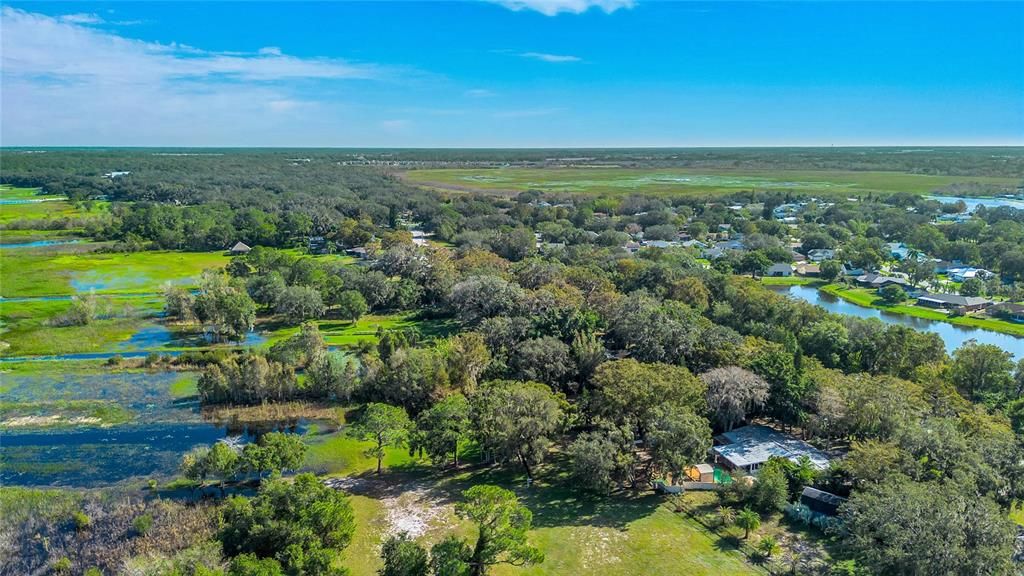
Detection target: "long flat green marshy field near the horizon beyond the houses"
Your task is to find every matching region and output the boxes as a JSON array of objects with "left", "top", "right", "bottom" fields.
[{"left": 402, "top": 168, "right": 1019, "bottom": 196}]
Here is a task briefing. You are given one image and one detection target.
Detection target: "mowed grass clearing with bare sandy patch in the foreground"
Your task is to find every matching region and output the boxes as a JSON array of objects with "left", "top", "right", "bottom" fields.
[{"left": 329, "top": 457, "right": 763, "bottom": 576}]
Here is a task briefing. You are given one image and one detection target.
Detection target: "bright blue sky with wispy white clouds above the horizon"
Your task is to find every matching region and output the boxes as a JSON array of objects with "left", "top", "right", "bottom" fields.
[{"left": 0, "top": 0, "right": 1024, "bottom": 147}]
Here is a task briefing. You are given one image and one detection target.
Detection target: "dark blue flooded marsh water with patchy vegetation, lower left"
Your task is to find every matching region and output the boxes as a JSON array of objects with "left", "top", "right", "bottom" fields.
[{"left": 0, "top": 370, "right": 327, "bottom": 487}]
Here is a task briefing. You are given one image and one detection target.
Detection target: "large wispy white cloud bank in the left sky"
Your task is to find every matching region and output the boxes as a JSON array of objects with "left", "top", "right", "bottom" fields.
[{"left": 0, "top": 7, "right": 394, "bottom": 146}]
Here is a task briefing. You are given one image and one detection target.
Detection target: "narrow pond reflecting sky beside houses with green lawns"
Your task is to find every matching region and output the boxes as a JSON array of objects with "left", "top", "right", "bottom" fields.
[{"left": 774, "top": 286, "right": 1024, "bottom": 358}]
